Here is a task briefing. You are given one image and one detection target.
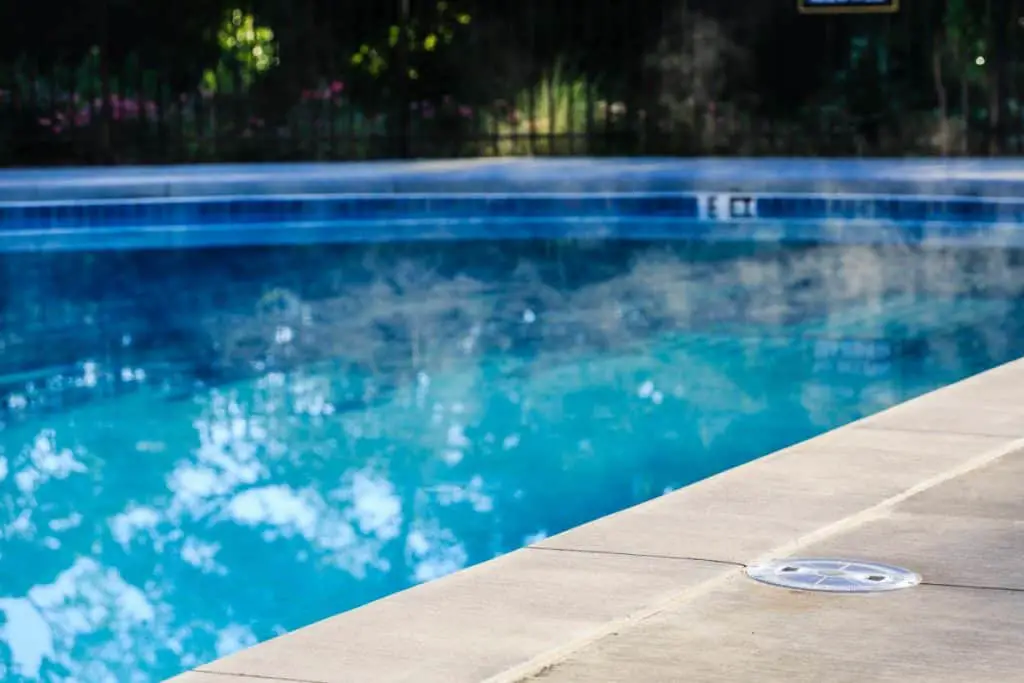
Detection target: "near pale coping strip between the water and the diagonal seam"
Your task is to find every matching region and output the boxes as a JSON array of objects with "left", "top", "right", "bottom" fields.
[{"left": 172, "top": 352, "right": 1024, "bottom": 683}]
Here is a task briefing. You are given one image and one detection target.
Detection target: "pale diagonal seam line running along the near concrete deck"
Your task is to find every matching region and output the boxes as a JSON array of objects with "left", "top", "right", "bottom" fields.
[{"left": 483, "top": 431, "right": 1024, "bottom": 683}]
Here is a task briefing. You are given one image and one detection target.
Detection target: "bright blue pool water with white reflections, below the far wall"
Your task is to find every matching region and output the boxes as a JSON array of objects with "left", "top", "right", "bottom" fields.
[{"left": 0, "top": 237, "right": 1024, "bottom": 683}]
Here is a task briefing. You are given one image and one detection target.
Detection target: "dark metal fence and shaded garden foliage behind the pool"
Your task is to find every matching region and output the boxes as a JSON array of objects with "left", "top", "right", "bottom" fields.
[{"left": 0, "top": 0, "right": 1024, "bottom": 166}]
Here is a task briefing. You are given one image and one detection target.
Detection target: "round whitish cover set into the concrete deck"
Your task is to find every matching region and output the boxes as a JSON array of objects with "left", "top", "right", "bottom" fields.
[{"left": 746, "top": 557, "right": 921, "bottom": 593}]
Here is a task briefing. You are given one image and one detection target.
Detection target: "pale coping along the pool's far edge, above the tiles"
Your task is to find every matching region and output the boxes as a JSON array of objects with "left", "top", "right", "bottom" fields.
[{"left": 6, "top": 158, "right": 1024, "bottom": 202}]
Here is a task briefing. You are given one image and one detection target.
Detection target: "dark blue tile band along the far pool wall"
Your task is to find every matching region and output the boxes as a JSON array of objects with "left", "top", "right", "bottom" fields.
[{"left": 0, "top": 193, "right": 1024, "bottom": 236}]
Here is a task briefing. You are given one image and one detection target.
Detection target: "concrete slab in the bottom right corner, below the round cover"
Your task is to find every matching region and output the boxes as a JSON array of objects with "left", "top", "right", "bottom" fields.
[{"left": 530, "top": 575, "right": 1024, "bottom": 683}]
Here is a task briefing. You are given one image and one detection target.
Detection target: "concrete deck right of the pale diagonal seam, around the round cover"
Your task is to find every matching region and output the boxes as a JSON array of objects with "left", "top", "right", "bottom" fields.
[{"left": 535, "top": 452, "right": 1024, "bottom": 683}]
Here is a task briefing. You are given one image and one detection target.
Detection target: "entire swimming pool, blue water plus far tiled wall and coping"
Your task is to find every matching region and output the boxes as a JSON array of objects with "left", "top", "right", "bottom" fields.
[{"left": 0, "top": 160, "right": 1024, "bottom": 682}]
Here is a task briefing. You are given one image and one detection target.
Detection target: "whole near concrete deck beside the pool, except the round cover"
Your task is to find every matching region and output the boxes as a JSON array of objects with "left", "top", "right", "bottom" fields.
[{"left": 167, "top": 360, "right": 1024, "bottom": 683}]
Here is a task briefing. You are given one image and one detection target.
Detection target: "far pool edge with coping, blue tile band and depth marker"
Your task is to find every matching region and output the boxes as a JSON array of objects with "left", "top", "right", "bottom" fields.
[{"left": 0, "top": 159, "right": 1024, "bottom": 252}]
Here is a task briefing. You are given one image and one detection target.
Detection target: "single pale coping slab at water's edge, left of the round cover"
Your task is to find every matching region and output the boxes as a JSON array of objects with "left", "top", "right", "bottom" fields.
[{"left": 193, "top": 551, "right": 727, "bottom": 683}]
